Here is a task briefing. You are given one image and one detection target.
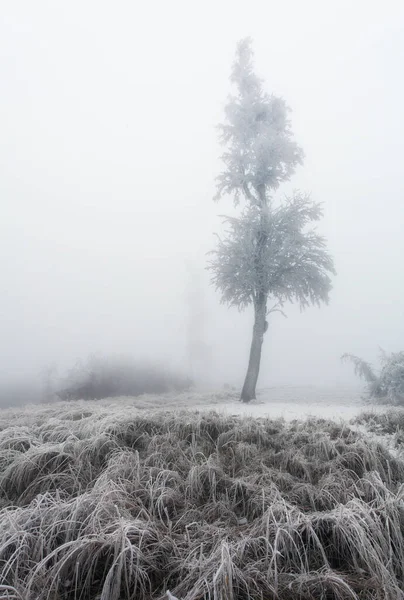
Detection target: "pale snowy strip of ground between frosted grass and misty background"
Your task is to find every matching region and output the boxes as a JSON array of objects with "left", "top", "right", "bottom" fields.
[{"left": 0, "top": 386, "right": 386, "bottom": 426}]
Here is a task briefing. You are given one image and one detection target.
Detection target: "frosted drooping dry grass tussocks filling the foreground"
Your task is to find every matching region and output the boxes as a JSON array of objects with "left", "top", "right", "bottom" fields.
[{"left": 0, "top": 404, "right": 404, "bottom": 600}]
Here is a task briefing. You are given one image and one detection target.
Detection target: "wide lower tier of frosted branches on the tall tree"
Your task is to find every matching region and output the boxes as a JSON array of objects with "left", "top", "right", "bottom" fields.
[{"left": 209, "top": 194, "right": 334, "bottom": 309}]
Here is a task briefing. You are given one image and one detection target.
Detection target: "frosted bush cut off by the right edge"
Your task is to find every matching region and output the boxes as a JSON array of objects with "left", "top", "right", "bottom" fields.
[{"left": 341, "top": 352, "right": 404, "bottom": 405}]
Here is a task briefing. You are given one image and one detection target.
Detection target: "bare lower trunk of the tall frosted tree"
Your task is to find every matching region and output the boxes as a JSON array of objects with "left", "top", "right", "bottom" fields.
[{"left": 240, "top": 298, "right": 267, "bottom": 402}]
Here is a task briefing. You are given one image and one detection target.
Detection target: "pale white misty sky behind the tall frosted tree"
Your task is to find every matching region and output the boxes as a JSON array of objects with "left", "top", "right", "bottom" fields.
[{"left": 0, "top": 0, "right": 404, "bottom": 385}]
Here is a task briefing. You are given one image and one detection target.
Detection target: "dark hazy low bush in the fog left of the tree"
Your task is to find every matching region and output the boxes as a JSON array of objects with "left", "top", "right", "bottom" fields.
[{"left": 56, "top": 357, "right": 191, "bottom": 400}]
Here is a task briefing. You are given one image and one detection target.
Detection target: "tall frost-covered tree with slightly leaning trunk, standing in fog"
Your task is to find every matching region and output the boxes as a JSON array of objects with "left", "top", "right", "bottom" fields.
[{"left": 209, "top": 39, "right": 334, "bottom": 402}]
